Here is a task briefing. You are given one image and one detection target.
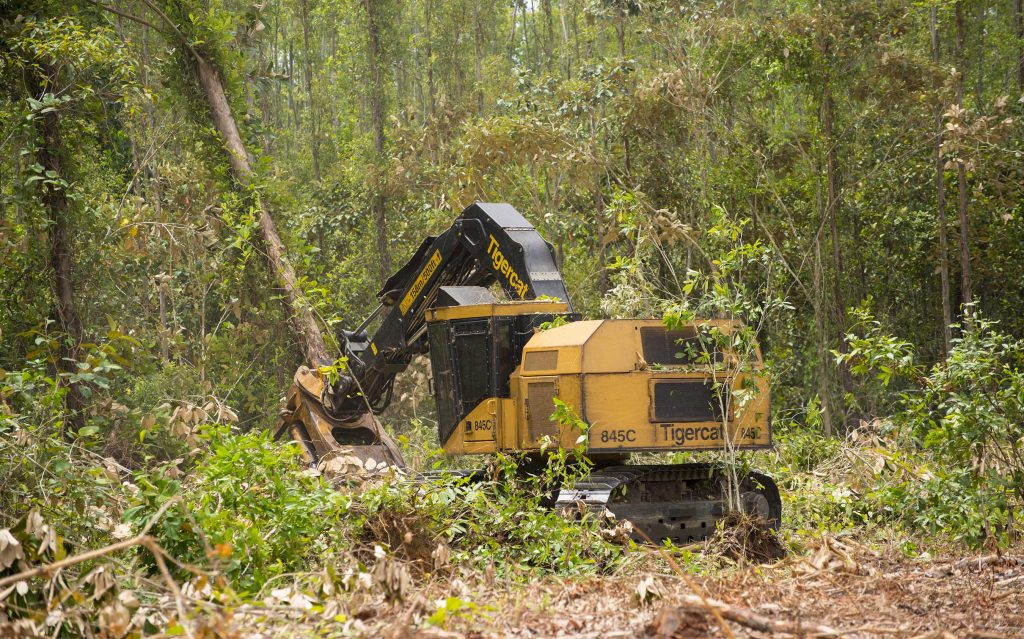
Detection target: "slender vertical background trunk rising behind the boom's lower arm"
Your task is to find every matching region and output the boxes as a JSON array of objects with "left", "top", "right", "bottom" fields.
[{"left": 362, "top": 0, "right": 391, "bottom": 282}]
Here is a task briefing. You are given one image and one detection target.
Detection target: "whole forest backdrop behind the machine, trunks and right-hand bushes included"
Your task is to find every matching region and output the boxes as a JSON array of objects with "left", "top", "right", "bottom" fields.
[{"left": 0, "top": 0, "right": 1024, "bottom": 634}]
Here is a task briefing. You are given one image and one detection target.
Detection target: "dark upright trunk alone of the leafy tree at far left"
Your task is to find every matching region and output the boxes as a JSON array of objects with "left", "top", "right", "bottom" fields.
[{"left": 30, "top": 62, "right": 85, "bottom": 435}]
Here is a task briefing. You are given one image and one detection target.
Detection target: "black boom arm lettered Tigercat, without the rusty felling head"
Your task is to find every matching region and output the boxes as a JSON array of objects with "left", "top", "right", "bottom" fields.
[{"left": 334, "top": 203, "right": 571, "bottom": 415}]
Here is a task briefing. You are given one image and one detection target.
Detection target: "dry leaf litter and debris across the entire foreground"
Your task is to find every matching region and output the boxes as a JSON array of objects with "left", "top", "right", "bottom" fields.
[{"left": 0, "top": 512, "right": 1024, "bottom": 639}]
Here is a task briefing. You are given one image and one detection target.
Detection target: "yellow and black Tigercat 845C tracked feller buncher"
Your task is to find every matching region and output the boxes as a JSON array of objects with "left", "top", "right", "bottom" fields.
[{"left": 278, "top": 203, "right": 781, "bottom": 543}]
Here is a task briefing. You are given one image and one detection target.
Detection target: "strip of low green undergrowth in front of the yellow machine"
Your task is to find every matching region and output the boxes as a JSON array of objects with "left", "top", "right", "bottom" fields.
[{"left": 124, "top": 425, "right": 624, "bottom": 592}]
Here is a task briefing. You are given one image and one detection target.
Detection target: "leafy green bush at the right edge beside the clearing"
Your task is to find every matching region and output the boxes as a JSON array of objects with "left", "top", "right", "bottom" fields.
[{"left": 840, "top": 309, "right": 1024, "bottom": 545}]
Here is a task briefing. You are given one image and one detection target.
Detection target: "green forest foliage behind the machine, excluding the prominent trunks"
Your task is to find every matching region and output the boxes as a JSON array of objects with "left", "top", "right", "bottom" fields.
[{"left": 0, "top": 0, "right": 1024, "bottom": 430}]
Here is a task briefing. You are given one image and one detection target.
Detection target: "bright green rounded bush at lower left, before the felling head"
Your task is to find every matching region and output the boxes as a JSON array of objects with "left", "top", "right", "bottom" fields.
[{"left": 125, "top": 425, "right": 351, "bottom": 590}]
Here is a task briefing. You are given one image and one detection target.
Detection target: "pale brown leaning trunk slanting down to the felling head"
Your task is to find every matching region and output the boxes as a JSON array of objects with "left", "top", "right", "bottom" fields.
[{"left": 195, "top": 58, "right": 332, "bottom": 367}]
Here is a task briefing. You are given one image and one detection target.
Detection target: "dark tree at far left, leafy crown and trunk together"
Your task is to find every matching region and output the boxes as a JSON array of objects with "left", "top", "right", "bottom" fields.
[{"left": 0, "top": 13, "right": 132, "bottom": 435}]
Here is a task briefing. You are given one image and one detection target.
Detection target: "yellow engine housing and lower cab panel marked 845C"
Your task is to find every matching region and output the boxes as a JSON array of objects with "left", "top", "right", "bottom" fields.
[{"left": 438, "top": 309, "right": 771, "bottom": 455}]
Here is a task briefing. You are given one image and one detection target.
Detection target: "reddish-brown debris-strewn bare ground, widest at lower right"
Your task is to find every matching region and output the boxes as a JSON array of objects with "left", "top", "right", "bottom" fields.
[{"left": 232, "top": 539, "right": 1024, "bottom": 639}]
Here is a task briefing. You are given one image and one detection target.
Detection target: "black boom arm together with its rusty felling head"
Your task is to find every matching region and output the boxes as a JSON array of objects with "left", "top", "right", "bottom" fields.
[{"left": 278, "top": 203, "right": 569, "bottom": 469}]
